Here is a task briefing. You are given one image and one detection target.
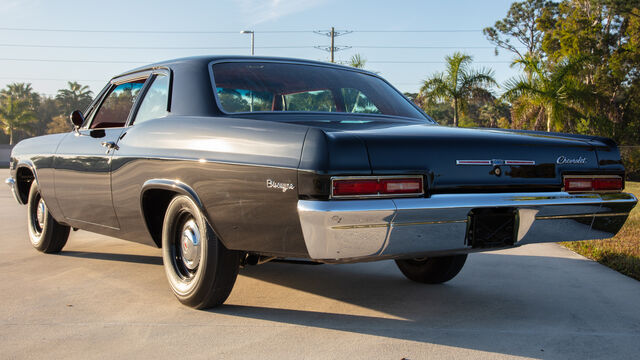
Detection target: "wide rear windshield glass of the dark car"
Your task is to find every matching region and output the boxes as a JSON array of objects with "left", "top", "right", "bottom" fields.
[{"left": 213, "top": 62, "right": 425, "bottom": 120}]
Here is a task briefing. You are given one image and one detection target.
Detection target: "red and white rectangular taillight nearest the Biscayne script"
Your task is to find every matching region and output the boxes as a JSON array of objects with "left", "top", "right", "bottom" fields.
[{"left": 331, "top": 176, "right": 424, "bottom": 198}]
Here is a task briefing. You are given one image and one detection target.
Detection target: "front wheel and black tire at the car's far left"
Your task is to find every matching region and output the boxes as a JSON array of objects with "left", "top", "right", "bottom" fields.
[{"left": 27, "top": 181, "right": 70, "bottom": 254}]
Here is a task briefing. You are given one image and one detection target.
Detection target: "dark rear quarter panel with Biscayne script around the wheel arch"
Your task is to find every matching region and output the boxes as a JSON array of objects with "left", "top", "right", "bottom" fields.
[{"left": 112, "top": 117, "right": 306, "bottom": 256}]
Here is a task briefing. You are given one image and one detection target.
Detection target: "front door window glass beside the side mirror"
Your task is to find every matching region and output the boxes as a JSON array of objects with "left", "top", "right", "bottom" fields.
[{"left": 90, "top": 79, "right": 146, "bottom": 129}]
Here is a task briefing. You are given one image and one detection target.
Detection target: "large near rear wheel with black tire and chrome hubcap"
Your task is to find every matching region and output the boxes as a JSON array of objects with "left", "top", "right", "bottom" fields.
[{"left": 162, "top": 195, "right": 240, "bottom": 309}]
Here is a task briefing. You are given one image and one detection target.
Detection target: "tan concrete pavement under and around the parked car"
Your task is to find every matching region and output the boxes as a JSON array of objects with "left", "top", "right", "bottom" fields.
[{"left": 0, "top": 171, "right": 640, "bottom": 360}]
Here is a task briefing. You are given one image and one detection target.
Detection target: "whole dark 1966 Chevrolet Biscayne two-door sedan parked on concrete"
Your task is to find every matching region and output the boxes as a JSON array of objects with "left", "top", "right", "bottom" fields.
[{"left": 7, "top": 57, "right": 636, "bottom": 308}]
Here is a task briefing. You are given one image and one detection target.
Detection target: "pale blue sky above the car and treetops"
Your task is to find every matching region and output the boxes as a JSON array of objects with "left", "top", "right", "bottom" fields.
[{"left": 0, "top": 0, "right": 517, "bottom": 95}]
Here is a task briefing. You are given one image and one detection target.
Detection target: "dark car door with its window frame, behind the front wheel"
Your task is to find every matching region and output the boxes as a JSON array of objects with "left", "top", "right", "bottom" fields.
[{"left": 54, "top": 74, "right": 148, "bottom": 230}]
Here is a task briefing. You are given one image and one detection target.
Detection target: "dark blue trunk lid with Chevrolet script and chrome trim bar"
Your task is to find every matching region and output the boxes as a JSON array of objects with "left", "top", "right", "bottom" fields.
[{"left": 332, "top": 124, "right": 602, "bottom": 193}]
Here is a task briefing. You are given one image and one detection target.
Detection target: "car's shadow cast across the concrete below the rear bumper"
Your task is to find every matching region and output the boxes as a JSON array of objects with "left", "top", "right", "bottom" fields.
[{"left": 216, "top": 254, "right": 640, "bottom": 358}]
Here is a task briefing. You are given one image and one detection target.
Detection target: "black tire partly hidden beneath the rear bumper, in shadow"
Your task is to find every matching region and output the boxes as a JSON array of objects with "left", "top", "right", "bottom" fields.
[{"left": 396, "top": 254, "right": 467, "bottom": 284}]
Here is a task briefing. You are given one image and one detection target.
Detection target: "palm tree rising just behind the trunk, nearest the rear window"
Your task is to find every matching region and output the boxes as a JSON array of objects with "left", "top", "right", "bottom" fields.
[{"left": 420, "top": 52, "right": 496, "bottom": 126}]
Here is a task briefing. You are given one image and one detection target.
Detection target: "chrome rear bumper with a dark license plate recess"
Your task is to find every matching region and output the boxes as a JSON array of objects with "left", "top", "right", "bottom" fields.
[{"left": 298, "top": 192, "right": 637, "bottom": 261}]
